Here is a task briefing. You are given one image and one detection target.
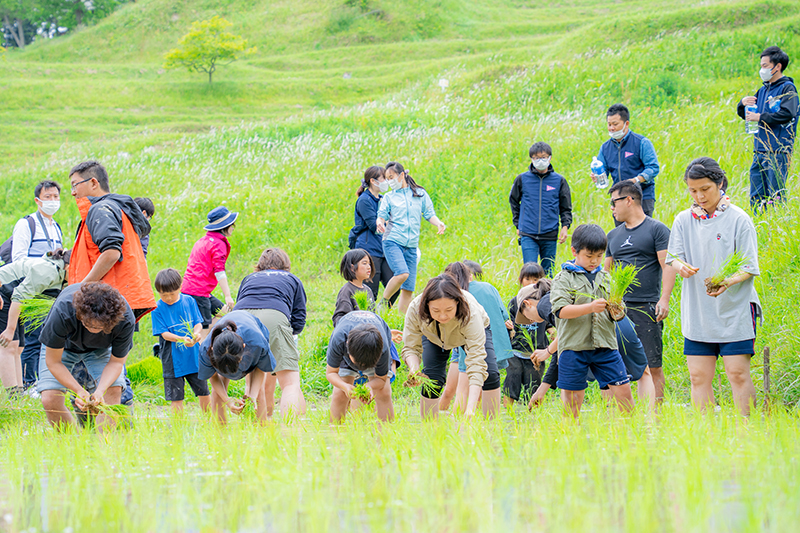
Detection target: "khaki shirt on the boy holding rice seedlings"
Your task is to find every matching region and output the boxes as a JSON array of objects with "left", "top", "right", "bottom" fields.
[{"left": 550, "top": 270, "right": 617, "bottom": 354}]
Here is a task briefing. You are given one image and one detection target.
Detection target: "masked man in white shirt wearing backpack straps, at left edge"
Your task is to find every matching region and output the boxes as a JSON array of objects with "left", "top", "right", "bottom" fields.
[{"left": 0, "top": 180, "right": 64, "bottom": 389}]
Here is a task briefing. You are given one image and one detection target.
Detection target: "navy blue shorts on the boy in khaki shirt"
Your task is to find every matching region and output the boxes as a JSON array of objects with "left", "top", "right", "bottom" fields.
[{"left": 556, "top": 348, "right": 631, "bottom": 391}]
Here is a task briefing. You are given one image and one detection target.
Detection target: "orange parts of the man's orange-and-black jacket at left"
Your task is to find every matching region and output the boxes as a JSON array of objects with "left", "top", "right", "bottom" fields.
[{"left": 69, "top": 198, "right": 156, "bottom": 320}]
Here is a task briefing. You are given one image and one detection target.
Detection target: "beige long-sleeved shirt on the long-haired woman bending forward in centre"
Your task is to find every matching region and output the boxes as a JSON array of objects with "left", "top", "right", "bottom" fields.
[{"left": 402, "top": 291, "right": 489, "bottom": 387}]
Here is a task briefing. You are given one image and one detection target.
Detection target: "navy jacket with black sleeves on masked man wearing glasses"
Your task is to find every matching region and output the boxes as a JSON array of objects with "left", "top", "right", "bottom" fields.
[{"left": 508, "top": 165, "right": 572, "bottom": 240}]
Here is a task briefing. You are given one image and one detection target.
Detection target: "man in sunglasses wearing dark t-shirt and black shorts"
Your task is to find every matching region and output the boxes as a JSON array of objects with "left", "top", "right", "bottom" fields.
[{"left": 605, "top": 181, "right": 675, "bottom": 402}]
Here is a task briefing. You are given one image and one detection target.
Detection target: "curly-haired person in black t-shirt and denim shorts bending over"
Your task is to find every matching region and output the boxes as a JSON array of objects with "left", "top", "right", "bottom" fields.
[{"left": 36, "top": 282, "right": 136, "bottom": 426}]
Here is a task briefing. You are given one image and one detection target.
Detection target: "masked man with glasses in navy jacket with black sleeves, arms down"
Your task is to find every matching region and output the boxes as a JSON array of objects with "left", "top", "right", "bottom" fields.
[{"left": 509, "top": 142, "right": 572, "bottom": 275}]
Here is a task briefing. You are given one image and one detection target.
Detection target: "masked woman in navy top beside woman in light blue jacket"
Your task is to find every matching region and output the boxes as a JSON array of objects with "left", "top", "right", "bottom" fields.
[{"left": 348, "top": 166, "right": 399, "bottom": 304}]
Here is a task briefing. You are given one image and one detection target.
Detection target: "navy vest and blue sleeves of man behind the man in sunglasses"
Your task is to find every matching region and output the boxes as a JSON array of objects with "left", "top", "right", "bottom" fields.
[{"left": 599, "top": 131, "right": 660, "bottom": 200}]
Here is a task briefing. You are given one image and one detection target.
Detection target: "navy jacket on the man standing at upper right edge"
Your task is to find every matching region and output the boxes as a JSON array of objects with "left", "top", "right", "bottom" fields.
[{"left": 736, "top": 76, "right": 798, "bottom": 154}]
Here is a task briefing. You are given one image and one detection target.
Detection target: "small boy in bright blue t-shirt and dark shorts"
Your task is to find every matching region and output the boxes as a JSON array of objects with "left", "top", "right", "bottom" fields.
[{"left": 152, "top": 268, "right": 211, "bottom": 413}]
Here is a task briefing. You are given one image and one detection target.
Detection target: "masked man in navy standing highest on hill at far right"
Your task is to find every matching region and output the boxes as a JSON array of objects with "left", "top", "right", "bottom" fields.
[{"left": 737, "top": 46, "right": 798, "bottom": 210}]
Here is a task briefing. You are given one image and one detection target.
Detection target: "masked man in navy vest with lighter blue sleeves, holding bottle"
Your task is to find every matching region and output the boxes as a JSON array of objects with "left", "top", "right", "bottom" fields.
[{"left": 592, "top": 104, "right": 660, "bottom": 225}]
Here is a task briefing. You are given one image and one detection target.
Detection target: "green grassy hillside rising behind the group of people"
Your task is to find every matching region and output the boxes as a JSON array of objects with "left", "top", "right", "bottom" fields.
[{"left": 0, "top": 0, "right": 800, "bottom": 402}]
